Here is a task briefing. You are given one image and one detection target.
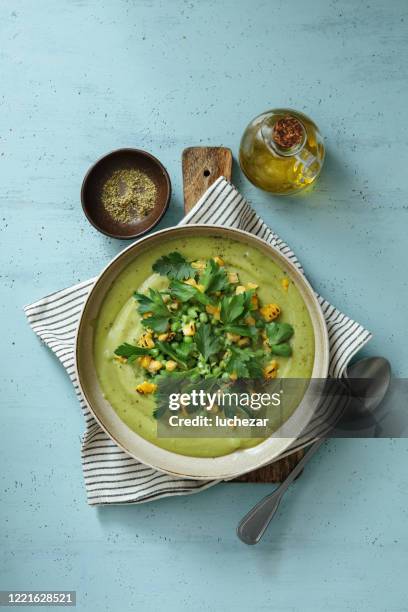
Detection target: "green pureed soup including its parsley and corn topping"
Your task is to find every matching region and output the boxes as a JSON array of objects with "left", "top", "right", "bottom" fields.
[{"left": 94, "top": 236, "right": 314, "bottom": 457}]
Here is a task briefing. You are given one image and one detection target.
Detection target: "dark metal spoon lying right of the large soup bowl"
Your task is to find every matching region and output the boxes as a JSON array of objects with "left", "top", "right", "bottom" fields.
[{"left": 237, "top": 357, "right": 391, "bottom": 544}]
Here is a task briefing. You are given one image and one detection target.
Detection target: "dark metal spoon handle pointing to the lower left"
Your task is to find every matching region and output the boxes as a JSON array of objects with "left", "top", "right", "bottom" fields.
[{"left": 237, "top": 438, "right": 325, "bottom": 544}]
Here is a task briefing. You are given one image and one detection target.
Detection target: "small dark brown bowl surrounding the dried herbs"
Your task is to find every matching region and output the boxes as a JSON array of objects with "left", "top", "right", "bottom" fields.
[{"left": 81, "top": 149, "right": 171, "bottom": 240}]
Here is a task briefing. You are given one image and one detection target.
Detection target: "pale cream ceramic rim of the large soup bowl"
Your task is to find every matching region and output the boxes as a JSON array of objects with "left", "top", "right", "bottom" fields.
[{"left": 75, "top": 224, "right": 329, "bottom": 480}]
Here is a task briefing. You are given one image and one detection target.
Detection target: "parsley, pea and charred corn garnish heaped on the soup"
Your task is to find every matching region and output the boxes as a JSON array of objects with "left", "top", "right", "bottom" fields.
[{"left": 115, "top": 251, "right": 294, "bottom": 400}]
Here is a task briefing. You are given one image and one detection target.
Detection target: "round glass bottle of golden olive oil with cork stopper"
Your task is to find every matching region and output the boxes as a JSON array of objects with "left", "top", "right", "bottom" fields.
[{"left": 239, "top": 108, "right": 324, "bottom": 195}]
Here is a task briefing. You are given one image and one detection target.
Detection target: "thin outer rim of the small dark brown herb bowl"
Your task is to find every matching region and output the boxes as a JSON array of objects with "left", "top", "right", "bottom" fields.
[{"left": 80, "top": 147, "right": 172, "bottom": 240}]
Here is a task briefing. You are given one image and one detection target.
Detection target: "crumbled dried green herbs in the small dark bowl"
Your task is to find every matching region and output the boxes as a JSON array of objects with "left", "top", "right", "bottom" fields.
[{"left": 102, "top": 168, "right": 157, "bottom": 223}]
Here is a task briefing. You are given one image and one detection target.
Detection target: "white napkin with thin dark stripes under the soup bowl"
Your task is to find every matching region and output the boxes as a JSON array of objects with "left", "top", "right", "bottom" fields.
[{"left": 24, "top": 177, "right": 371, "bottom": 505}]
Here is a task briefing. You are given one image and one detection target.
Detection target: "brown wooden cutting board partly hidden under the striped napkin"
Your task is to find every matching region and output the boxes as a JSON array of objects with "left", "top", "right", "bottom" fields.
[{"left": 182, "top": 147, "right": 303, "bottom": 482}]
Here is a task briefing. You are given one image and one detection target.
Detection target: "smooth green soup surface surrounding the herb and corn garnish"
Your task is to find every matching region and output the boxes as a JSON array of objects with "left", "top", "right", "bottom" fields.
[{"left": 94, "top": 237, "right": 314, "bottom": 457}]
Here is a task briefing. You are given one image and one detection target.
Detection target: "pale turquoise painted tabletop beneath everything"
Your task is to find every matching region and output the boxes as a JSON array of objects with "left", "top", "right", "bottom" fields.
[{"left": 0, "top": 0, "right": 408, "bottom": 612}]
